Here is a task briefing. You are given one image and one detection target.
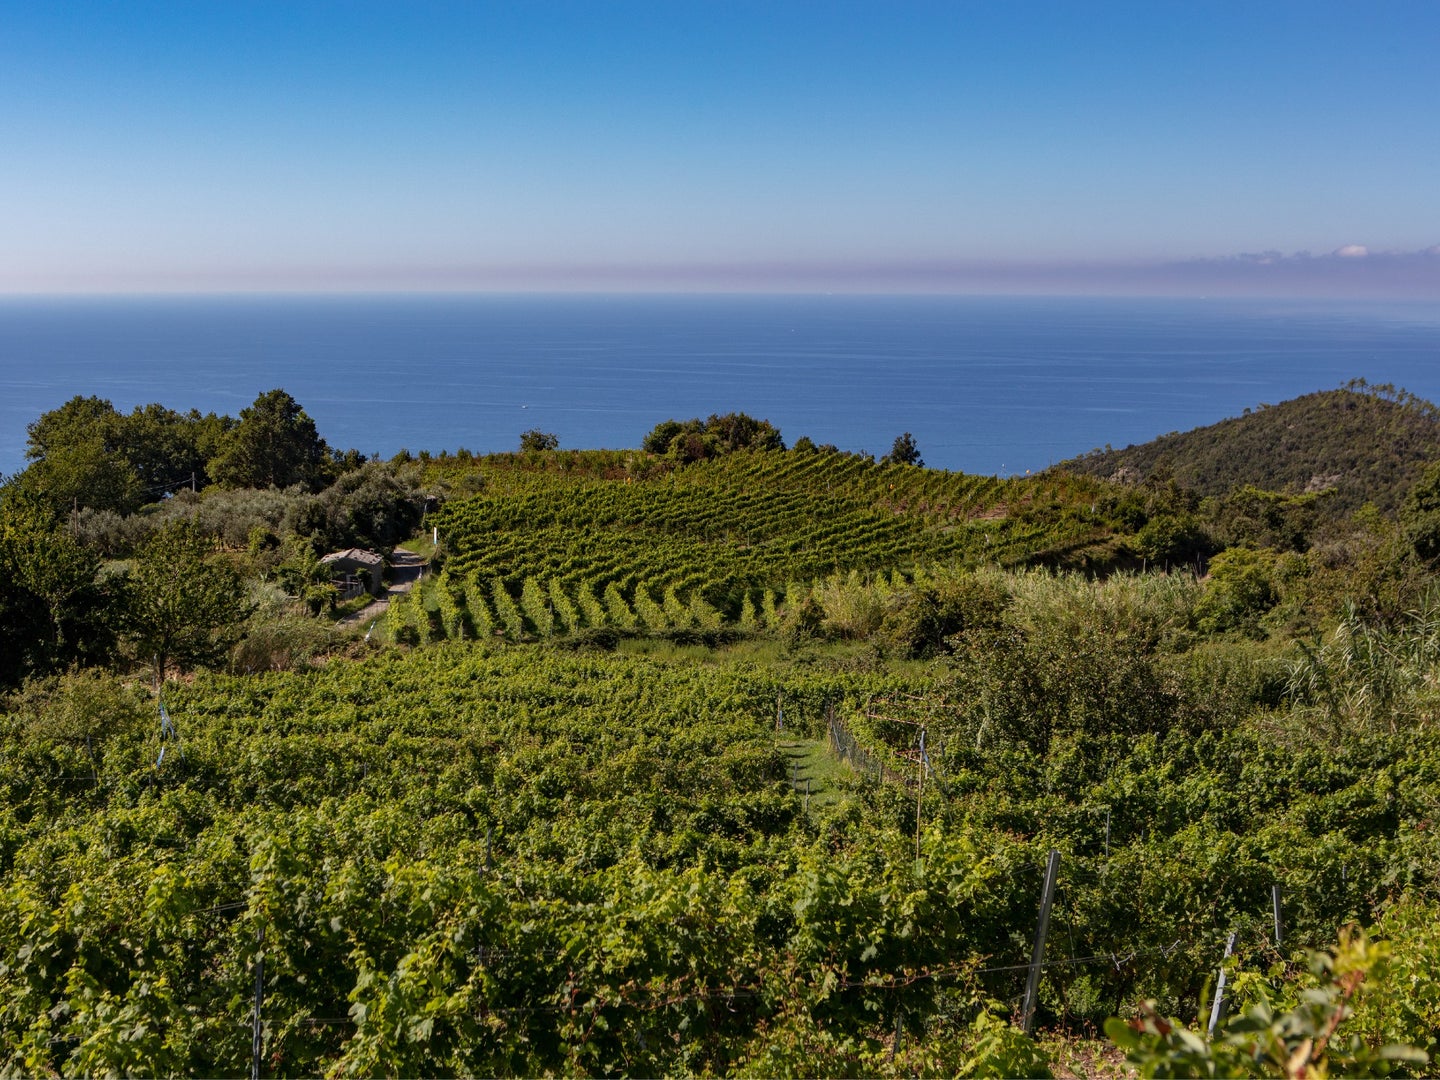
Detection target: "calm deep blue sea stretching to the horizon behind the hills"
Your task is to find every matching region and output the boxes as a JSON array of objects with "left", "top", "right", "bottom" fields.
[{"left": 0, "top": 297, "right": 1440, "bottom": 474}]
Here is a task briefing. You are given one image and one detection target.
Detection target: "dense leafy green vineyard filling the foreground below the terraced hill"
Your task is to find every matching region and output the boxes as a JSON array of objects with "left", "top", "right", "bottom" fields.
[{"left": 0, "top": 575, "right": 1440, "bottom": 1076}]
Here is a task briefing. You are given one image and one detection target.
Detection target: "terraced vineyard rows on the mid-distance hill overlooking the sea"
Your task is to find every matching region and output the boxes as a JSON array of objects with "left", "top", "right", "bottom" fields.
[{"left": 423, "top": 452, "right": 1109, "bottom": 638}]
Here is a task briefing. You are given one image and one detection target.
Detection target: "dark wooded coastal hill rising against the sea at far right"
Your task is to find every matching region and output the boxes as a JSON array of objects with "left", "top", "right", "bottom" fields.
[{"left": 1060, "top": 380, "right": 1440, "bottom": 514}]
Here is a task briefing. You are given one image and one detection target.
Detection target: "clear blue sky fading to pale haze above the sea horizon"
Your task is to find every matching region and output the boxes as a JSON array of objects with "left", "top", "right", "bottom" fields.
[{"left": 0, "top": 0, "right": 1440, "bottom": 298}]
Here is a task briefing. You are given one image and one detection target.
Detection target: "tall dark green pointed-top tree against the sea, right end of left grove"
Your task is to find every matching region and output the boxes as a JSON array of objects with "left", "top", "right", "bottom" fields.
[{"left": 210, "top": 390, "right": 330, "bottom": 491}]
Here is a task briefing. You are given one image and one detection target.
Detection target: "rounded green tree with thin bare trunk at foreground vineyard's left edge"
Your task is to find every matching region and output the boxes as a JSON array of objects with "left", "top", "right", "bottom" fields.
[{"left": 125, "top": 521, "right": 249, "bottom": 684}]
